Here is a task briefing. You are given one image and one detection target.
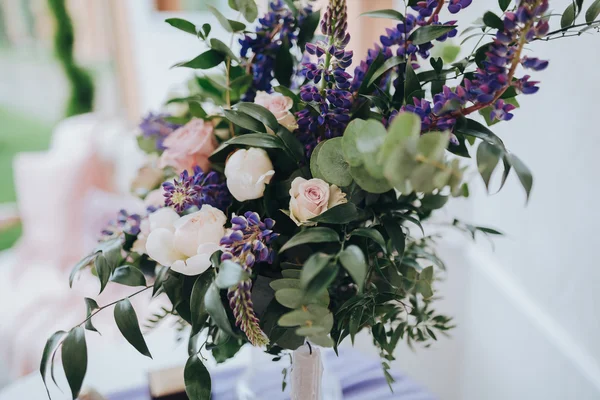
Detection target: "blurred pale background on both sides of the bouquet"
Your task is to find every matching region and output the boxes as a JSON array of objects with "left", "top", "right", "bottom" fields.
[{"left": 0, "top": 0, "right": 600, "bottom": 400}]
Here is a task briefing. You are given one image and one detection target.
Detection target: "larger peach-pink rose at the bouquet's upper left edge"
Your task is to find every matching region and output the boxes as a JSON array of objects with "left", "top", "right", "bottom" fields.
[{"left": 159, "top": 118, "right": 217, "bottom": 172}]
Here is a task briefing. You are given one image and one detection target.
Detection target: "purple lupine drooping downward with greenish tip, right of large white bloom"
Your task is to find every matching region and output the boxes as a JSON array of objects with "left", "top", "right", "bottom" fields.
[{"left": 221, "top": 211, "right": 279, "bottom": 346}]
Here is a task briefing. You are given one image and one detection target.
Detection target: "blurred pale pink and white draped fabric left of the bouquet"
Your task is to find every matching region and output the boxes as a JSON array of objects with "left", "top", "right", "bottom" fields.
[{"left": 0, "top": 115, "right": 162, "bottom": 377}]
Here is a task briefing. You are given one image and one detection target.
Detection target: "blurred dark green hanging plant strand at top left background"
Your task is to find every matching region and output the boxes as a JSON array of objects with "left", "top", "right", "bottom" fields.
[{"left": 48, "top": 0, "right": 94, "bottom": 117}]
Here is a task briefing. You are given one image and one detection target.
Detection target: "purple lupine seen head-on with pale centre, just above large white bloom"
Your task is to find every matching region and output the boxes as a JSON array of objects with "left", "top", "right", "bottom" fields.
[{"left": 163, "top": 166, "right": 232, "bottom": 213}]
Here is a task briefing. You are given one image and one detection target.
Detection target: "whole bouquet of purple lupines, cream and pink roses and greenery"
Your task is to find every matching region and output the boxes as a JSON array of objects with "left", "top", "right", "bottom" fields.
[{"left": 40, "top": 0, "right": 600, "bottom": 400}]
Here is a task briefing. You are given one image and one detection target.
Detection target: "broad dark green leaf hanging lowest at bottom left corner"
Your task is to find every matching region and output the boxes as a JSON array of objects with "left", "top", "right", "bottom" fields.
[{"left": 61, "top": 326, "right": 87, "bottom": 399}]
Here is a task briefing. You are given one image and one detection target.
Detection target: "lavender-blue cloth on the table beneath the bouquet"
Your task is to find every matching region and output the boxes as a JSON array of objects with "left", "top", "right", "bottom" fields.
[{"left": 108, "top": 350, "right": 437, "bottom": 400}]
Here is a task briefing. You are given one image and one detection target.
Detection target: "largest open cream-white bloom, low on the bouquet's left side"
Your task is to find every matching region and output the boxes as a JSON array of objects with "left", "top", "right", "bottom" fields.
[{"left": 146, "top": 204, "right": 227, "bottom": 276}]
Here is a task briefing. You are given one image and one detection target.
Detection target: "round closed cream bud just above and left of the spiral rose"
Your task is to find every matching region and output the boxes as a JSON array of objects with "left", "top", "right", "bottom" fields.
[{"left": 225, "top": 147, "right": 275, "bottom": 201}]
